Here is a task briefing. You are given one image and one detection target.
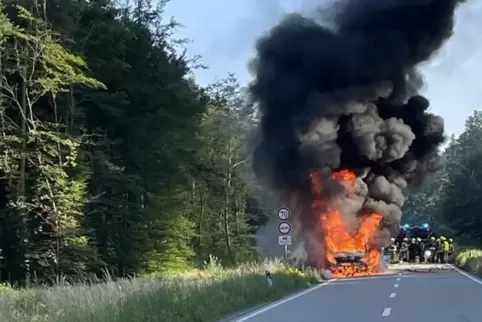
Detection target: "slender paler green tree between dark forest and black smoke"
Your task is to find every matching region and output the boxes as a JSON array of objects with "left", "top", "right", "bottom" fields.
[{"left": 193, "top": 75, "right": 262, "bottom": 264}]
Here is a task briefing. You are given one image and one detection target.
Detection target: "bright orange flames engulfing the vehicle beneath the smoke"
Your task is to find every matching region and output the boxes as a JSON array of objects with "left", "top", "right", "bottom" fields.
[{"left": 310, "top": 169, "right": 382, "bottom": 277}]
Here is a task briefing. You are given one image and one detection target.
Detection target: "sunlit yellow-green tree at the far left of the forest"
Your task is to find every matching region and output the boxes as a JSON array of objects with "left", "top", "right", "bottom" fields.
[{"left": 0, "top": 2, "right": 102, "bottom": 279}]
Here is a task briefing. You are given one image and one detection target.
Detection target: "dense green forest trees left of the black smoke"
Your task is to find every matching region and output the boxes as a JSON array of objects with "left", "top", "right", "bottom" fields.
[{"left": 0, "top": 0, "right": 264, "bottom": 283}]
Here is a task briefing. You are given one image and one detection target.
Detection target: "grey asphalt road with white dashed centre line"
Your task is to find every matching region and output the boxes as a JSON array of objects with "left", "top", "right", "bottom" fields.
[{"left": 233, "top": 268, "right": 482, "bottom": 322}]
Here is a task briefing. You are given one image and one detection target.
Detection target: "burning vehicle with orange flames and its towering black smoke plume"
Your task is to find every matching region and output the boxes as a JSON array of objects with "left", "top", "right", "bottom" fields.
[{"left": 250, "top": 0, "right": 463, "bottom": 277}]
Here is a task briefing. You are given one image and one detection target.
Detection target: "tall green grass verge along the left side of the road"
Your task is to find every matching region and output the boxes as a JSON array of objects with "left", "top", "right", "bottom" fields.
[{"left": 0, "top": 262, "right": 318, "bottom": 322}]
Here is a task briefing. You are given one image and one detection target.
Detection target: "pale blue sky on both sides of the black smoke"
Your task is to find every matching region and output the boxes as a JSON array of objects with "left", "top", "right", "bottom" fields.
[{"left": 166, "top": 0, "right": 482, "bottom": 135}]
